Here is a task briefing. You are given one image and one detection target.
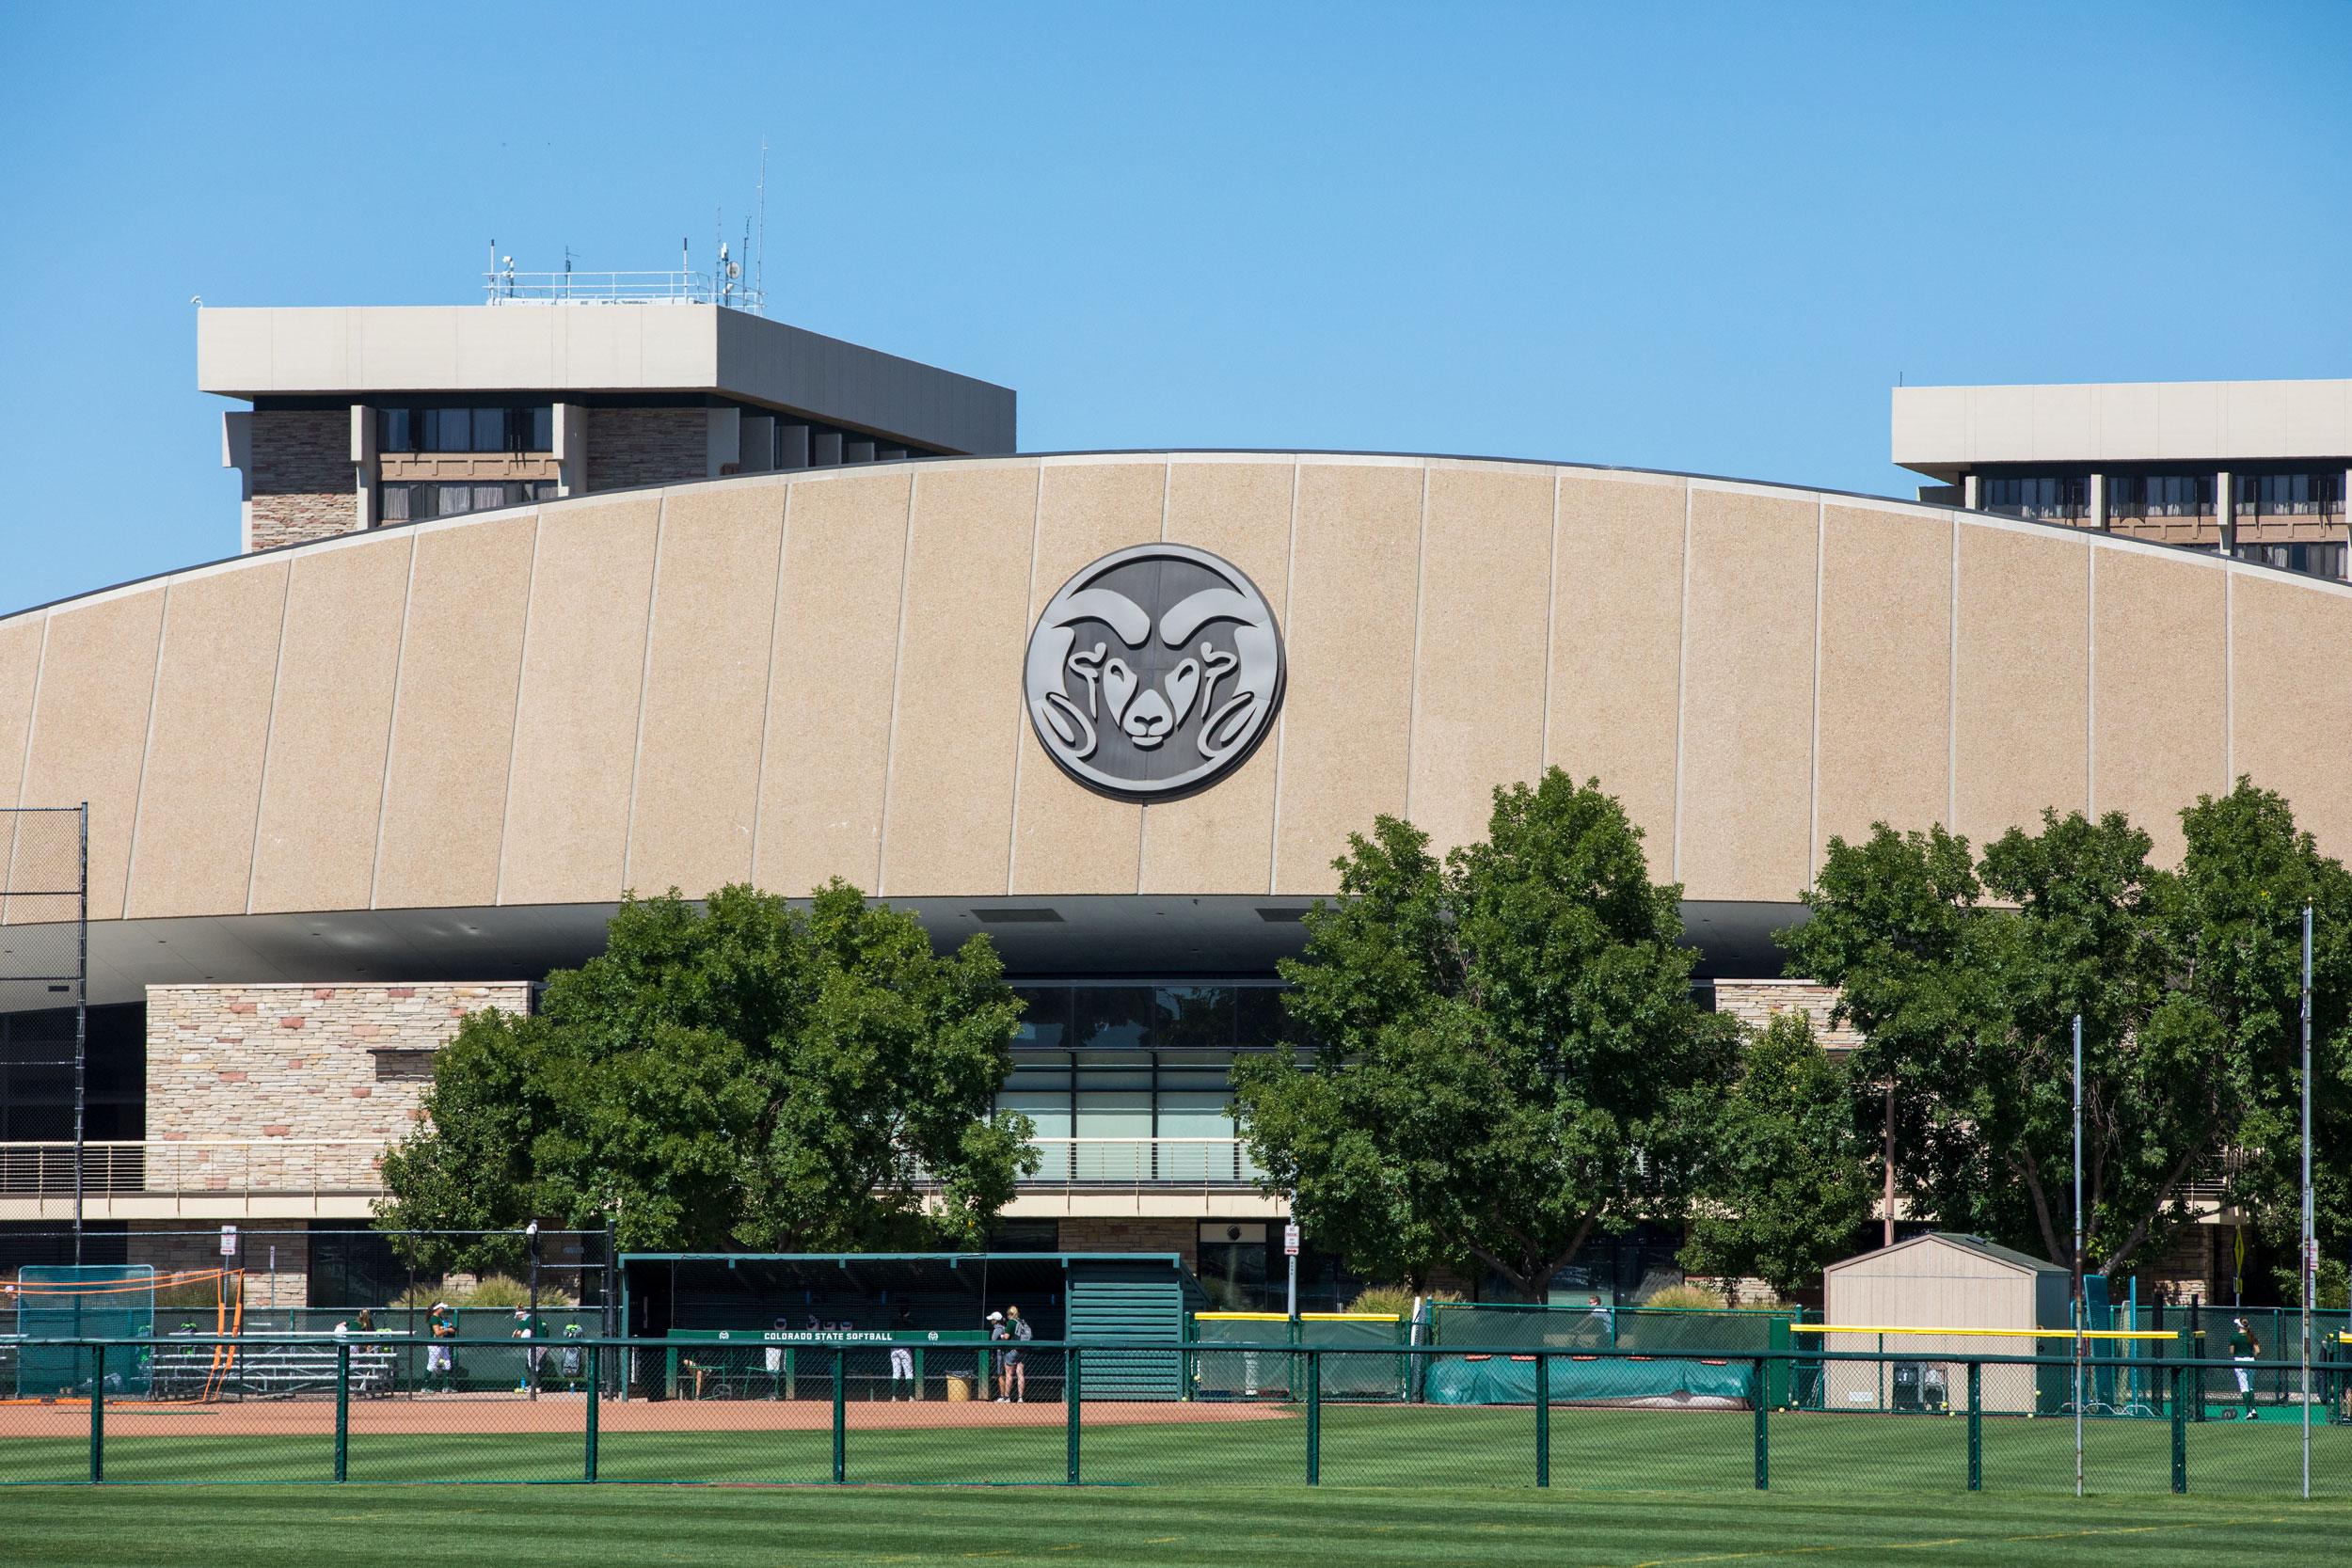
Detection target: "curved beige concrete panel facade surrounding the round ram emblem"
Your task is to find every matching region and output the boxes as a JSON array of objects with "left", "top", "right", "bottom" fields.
[{"left": 0, "top": 453, "right": 2352, "bottom": 919}]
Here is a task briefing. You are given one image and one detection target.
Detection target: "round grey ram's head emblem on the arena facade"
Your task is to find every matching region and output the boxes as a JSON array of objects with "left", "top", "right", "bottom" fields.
[{"left": 1024, "top": 546, "right": 1282, "bottom": 800}]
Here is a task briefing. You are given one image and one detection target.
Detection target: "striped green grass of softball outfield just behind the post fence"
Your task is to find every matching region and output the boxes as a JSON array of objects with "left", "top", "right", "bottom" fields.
[{"left": 0, "top": 1406, "right": 2352, "bottom": 1510}]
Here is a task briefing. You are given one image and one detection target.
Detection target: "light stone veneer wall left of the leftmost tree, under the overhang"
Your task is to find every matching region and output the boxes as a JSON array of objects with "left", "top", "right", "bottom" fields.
[{"left": 146, "top": 980, "right": 530, "bottom": 1192}]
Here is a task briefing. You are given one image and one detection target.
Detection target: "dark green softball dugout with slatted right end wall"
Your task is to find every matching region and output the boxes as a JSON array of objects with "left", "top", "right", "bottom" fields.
[{"left": 621, "top": 1253, "right": 1207, "bottom": 1399}]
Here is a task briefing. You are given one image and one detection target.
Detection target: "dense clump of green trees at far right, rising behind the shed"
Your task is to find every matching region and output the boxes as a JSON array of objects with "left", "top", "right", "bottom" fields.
[{"left": 1783, "top": 781, "right": 2352, "bottom": 1275}]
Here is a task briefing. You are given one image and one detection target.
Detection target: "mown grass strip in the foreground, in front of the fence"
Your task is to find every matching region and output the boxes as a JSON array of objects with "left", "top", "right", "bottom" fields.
[{"left": 0, "top": 1486, "right": 2352, "bottom": 1568}]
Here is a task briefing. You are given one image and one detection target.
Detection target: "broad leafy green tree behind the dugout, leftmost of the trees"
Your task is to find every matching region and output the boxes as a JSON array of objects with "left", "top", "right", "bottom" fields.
[{"left": 376, "top": 881, "right": 1035, "bottom": 1267}]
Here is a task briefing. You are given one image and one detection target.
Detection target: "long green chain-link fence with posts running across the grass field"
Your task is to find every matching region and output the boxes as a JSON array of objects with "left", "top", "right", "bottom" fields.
[{"left": 0, "top": 1331, "right": 2352, "bottom": 1497}]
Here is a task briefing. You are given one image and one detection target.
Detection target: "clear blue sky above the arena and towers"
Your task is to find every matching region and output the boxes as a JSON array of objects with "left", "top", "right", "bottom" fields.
[{"left": 0, "top": 0, "right": 2352, "bottom": 609}]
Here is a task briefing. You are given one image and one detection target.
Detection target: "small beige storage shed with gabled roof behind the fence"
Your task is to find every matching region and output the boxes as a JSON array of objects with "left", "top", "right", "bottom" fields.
[{"left": 1809, "top": 1232, "right": 2070, "bottom": 1416}]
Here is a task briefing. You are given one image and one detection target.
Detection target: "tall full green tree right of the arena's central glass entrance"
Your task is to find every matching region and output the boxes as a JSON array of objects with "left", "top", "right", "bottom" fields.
[{"left": 1232, "top": 768, "right": 1734, "bottom": 1300}]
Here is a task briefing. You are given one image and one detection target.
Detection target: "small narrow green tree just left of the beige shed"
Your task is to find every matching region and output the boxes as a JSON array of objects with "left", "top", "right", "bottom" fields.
[{"left": 1682, "top": 1011, "right": 1877, "bottom": 1295}]
